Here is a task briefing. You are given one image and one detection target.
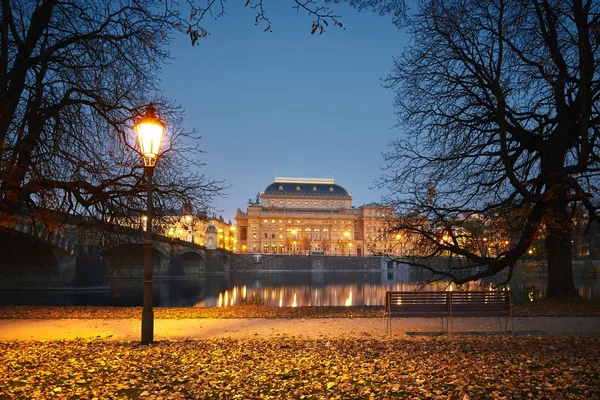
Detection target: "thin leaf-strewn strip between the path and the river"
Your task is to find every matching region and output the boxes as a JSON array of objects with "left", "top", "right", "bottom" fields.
[{"left": 0, "top": 300, "right": 600, "bottom": 319}]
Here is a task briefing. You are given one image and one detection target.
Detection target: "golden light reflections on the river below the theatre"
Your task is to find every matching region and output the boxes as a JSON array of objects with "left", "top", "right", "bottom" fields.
[{"left": 195, "top": 271, "right": 600, "bottom": 307}]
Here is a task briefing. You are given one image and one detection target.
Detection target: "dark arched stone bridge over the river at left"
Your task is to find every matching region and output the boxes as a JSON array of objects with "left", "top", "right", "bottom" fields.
[{"left": 0, "top": 218, "right": 231, "bottom": 289}]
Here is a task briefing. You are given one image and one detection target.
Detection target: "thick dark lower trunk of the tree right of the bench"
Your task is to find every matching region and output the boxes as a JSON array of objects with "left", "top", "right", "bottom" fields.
[{"left": 546, "top": 210, "right": 580, "bottom": 299}]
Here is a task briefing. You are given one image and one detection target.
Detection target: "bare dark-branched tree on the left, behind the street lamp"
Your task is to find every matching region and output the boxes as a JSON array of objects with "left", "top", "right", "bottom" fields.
[{"left": 0, "top": 0, "right": 227, "bottom": 231}]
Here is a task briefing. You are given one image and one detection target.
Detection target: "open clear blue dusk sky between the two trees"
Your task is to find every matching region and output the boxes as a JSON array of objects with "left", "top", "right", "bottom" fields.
[{"left": 162, "top": 0, "right": 408, "bottom": 221}]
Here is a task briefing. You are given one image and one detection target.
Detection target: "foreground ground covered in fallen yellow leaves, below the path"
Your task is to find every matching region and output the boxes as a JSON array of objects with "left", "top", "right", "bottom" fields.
[{"left": 0, "top": 336, "right": 600, "bottom": 400}]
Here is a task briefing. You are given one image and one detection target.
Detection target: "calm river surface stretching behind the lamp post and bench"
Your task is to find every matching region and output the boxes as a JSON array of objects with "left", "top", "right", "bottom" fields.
[{"left": 0, "top": 270, "right": 600, "bottom": 307}]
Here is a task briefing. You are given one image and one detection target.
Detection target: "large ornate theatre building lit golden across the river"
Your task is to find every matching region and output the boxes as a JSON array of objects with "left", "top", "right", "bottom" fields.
[{"left": 235, "top": 177, "right": 401, "bottom": 256}]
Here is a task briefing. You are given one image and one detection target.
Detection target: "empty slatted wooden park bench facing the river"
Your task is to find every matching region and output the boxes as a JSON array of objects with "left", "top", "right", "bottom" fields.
[{"left": 384, "top": 290, "right": 514, "bottom": 336}]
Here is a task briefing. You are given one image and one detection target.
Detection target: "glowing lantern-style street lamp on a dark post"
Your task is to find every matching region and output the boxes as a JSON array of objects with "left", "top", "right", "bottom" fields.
[{"left": 134, "top": 106, "right": 165, "bottom": 344}]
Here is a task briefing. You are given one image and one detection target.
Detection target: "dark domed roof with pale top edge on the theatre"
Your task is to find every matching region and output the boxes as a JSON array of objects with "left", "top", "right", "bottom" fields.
[{"left": 263, "top": 178, "right": 350, "bottom": 198}]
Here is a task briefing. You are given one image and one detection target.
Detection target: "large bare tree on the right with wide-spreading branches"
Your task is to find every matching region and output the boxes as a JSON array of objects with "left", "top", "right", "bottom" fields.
[{"left": 380, "top": 0, "right": 600, "bottom": 298}]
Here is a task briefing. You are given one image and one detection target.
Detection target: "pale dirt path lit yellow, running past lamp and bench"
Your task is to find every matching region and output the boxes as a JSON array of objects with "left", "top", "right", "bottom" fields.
[{"left": 0, "top": 317, "right": 600, "bottom": 341}]
